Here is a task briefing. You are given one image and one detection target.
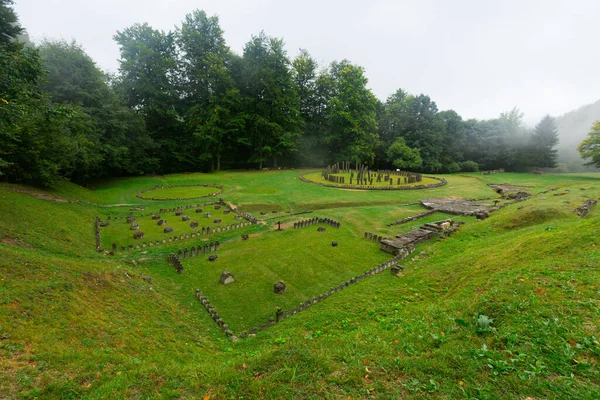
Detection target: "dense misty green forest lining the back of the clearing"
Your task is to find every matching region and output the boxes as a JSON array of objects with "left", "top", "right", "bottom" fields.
[{"left": 0, "top": 0, "right": 558, "bottom": 186}]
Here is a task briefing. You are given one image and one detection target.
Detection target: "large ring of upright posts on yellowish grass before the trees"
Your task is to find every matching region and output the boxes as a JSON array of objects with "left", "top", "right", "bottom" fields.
[{"left": 300, "top": 162, "right": 446, "bottom": 190}]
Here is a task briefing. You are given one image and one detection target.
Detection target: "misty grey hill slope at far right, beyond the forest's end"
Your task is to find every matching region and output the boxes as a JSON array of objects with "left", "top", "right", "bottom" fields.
[{"left": 556, "top": 100, "right": 600, "bottom": 172}]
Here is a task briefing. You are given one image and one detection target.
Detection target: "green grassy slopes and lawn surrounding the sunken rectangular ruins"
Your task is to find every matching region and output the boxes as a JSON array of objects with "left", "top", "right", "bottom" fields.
[{"left": 0, "top": 171, "right": 600, "bottom": 398}]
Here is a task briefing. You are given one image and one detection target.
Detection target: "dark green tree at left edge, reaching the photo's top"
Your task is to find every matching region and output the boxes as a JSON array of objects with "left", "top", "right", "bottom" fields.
[{"left": 0, "top": 0, "right": 85, "bottom": 186}]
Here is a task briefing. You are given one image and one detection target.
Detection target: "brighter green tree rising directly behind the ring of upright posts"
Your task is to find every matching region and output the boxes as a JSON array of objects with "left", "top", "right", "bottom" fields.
[{"left": 327, "top": 60, "right": 378, "bottom": 164}]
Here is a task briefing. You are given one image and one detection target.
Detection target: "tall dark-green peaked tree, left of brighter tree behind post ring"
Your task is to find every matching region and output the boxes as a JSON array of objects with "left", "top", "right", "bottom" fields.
[{"left": 240, "top": 32, "right": 302, "bottom": 169}]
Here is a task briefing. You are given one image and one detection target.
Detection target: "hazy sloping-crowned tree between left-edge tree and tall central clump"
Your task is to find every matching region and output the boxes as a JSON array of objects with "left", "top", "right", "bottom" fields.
[{"left": 39, "top": 40, "right": 153, "bottom": 182}]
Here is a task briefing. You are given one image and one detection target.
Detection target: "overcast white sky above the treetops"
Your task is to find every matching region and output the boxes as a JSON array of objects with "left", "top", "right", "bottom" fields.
[{"left": 15, "top": 0, "right": 600, "bottom": 124}]
